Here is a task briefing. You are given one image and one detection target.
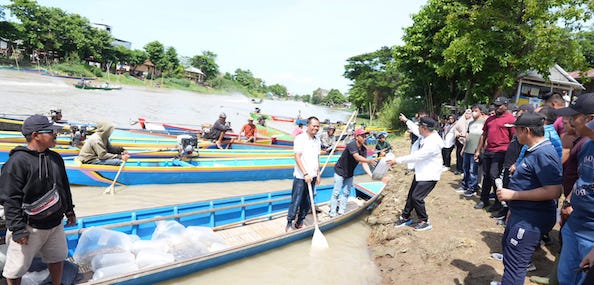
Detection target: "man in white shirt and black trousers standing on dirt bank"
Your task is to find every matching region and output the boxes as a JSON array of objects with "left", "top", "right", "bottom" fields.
[{"left": 391, "top": 117, "right": 444, "bottom": 231}]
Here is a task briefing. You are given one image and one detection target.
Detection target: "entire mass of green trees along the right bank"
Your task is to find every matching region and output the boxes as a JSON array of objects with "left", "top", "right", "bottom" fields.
[{"left": 344, "top": 0, "right": 594, "bottom": 125}]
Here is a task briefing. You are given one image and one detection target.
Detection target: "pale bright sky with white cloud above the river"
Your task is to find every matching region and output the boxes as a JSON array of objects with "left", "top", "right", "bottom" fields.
[{"left": 0, "top": 0, "right": 427, "bottom": 95}]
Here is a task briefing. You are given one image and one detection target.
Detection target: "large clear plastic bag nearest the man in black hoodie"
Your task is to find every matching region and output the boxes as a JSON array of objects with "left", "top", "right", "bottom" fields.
[{"left": 73, "top": 227, "right": 132, "bottom": 265}]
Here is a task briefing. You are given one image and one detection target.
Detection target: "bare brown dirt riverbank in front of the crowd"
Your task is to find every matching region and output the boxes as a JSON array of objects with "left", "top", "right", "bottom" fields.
[{"left": 367, "top": 137, "right": 559, "bottom": 284}]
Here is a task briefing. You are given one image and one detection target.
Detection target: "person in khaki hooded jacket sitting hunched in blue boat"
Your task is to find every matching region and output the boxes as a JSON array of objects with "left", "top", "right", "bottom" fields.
[{"left": 78, "top": 122, "right": 130, "bottom": 165}]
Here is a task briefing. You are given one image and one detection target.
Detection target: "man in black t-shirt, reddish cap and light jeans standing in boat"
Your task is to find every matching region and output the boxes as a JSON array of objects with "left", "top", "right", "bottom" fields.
[{"left": 329, "top": 128, "right": 375, "bottom": 217}]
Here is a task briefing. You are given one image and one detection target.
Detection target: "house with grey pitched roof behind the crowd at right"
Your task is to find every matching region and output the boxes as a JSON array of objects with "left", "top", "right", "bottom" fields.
[{"left": 515, "top": 64, "right": 586, "bottom": 107}]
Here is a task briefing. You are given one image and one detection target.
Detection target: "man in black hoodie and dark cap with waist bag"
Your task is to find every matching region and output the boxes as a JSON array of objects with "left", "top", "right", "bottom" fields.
[{"left": 0, "top": 115, "right": 76, "bottom": 284}]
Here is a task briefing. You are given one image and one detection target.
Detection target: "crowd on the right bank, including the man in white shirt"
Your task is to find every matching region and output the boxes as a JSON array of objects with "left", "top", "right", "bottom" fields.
[{"left": 392, "top": 93, "right": 594, "bottom": 284}]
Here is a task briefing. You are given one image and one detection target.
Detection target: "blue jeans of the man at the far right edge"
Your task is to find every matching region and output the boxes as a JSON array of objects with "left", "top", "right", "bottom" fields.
[{"left": 557, "top": 225, "right": 594, "bottom": 284}]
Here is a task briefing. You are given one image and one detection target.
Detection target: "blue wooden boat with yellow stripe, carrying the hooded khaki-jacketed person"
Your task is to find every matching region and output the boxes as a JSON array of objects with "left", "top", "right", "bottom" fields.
[{"left": 65, "top": 155, "right": 364, "bottom": 186}]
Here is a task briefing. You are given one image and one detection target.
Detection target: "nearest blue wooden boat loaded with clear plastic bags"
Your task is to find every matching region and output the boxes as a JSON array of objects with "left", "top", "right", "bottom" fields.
[{"left": 66, "top": 182, "right": 385, "bottom": 284}]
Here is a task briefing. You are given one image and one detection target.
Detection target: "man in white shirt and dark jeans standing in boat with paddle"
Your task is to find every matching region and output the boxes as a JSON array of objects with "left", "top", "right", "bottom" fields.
[{"left": 285, "top": 117, "right": 321, "bottom": 231}]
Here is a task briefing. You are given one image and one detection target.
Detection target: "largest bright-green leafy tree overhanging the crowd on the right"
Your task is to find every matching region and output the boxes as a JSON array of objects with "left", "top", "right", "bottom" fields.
[{"left": 394, "top": 0, "right": 593, "bottom": 112}]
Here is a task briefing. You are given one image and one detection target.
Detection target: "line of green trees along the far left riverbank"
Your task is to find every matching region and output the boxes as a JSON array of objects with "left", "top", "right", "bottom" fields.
[{"left": 0, "top": 0, "right": 346, "bottom": 104}]
